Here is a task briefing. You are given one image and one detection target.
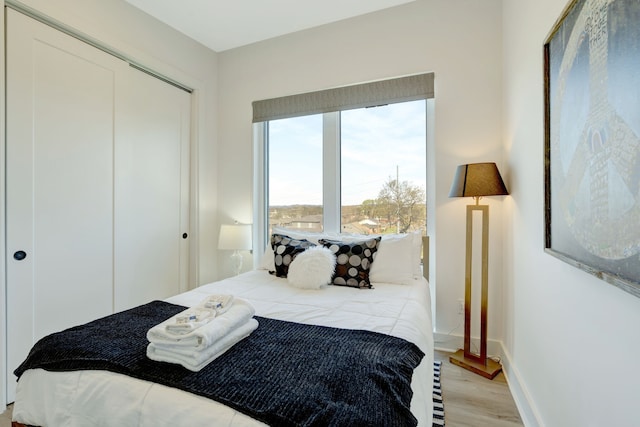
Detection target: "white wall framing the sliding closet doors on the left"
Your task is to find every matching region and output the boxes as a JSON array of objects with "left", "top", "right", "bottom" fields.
[{"left": 0, "top": 0, "right": 218, "bottom": 410}]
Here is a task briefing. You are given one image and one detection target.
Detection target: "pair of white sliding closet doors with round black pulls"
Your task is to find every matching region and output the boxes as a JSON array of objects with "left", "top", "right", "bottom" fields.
[{"left": 6, "top": 10, "right": 191, "bottom": 401}]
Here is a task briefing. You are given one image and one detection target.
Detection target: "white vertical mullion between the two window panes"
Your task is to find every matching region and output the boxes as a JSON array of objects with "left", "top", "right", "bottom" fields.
[{"left": 322, "top": 111, "right": 341, "bottom": 232}]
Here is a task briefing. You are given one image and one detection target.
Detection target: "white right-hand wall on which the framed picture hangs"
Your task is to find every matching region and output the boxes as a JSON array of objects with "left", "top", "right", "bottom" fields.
[{"left": 503, "top": 0, "right": 640, "bottom": 427}]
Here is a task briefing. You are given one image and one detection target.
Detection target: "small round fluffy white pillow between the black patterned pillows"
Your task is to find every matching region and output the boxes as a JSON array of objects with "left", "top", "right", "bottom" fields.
[{"left": 287, "top": 246, "right": 336, "bottom": 289}]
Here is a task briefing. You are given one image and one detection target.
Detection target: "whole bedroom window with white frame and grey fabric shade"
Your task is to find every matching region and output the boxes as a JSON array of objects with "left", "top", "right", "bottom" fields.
[{"left": 254, "top": 74, "right": 433, "bottom": 258}]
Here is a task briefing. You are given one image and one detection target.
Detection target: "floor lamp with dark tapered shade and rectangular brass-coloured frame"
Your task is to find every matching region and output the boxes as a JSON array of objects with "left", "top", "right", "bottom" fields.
[{"left": 449, "top": 163, "right": 509, "bottom": 379}]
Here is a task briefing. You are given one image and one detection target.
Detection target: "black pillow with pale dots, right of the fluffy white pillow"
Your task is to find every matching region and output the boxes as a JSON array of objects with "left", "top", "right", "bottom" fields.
[{"left": 319, "top": 236, "right": 381, "bottom": 288}]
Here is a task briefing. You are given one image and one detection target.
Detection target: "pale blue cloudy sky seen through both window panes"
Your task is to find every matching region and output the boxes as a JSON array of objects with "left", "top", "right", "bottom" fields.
[{"left": 269, "top": 101, "right": 426, "bottom": 206}]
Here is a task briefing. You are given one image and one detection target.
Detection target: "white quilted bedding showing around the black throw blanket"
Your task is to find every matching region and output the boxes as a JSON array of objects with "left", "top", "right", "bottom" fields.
[{"left": 13, "top": 270, "right": 433, "bottom": 427}]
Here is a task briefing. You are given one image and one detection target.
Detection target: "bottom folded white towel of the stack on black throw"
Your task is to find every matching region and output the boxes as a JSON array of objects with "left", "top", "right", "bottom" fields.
[{"left": 147, "top": 319, "right": 258, "bottom": 372}]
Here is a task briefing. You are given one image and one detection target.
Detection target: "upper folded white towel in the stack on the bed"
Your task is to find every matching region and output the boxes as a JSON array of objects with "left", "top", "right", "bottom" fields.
[{"left": 147, "top": 298, "right": 255, "bottom": 350}]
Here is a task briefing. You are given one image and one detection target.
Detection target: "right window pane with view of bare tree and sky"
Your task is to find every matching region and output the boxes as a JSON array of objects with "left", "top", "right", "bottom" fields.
[{"left": 340, "top": 100, "right": 427, "bottom": 234}]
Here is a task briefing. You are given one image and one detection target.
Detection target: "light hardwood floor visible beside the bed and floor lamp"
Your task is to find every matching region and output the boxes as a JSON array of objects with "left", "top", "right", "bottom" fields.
[{"left": 0, "top": 350, "right": 523, "bottom": 427}]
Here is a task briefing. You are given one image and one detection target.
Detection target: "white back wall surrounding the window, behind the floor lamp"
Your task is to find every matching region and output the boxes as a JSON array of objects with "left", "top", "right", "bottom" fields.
[{"left": 218, "top": 0, "right": 508, "bottom": 348}]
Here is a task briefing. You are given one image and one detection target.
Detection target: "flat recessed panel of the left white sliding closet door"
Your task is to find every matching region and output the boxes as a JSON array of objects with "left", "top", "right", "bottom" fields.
[{"left": 31, "top": 39, "right": 114, "bottom": 336}]
